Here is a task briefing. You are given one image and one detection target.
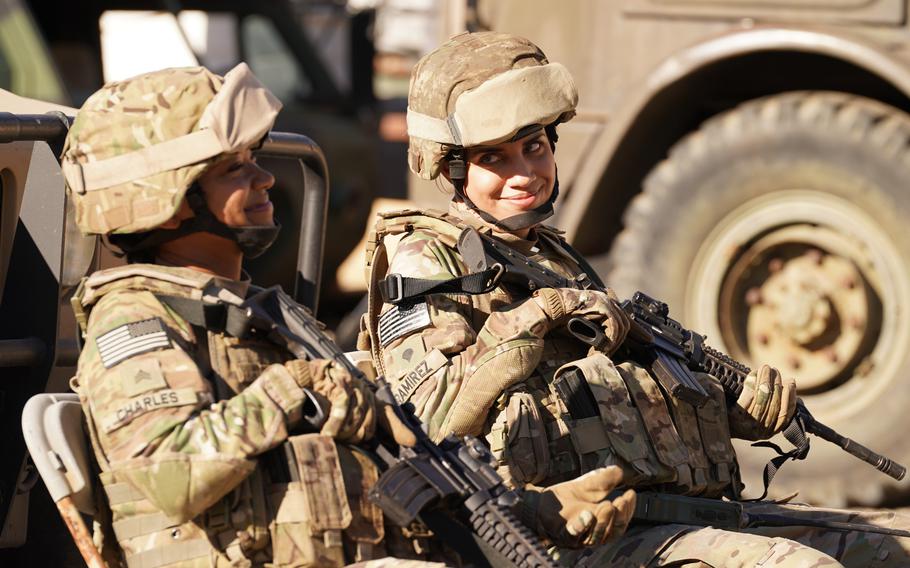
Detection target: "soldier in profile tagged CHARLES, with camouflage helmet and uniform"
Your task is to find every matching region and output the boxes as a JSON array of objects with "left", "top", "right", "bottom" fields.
[{"left": 62, "top": 64, "right": 634, "bottom": 568}]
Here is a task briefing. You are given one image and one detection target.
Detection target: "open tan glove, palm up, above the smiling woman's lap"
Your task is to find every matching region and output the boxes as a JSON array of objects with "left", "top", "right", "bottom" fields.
[{"left": 521, "top": 466, "right": 635, "bottom": 548}]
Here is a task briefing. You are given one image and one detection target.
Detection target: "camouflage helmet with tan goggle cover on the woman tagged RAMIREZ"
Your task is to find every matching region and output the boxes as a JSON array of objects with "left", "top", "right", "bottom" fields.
[{"left": 407, "top": 32, "right": 578, "bottom": 179}]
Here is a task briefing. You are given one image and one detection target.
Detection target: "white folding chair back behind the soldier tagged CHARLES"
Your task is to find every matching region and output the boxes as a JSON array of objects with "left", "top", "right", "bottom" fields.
[{"left": 22, "top": 393, "right": 106, "bottom": 568}]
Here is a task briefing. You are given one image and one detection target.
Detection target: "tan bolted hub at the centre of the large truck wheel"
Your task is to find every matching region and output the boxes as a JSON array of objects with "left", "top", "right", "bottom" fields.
[{"left": 724, "top": 234, "right": 872, "bottom": 392}]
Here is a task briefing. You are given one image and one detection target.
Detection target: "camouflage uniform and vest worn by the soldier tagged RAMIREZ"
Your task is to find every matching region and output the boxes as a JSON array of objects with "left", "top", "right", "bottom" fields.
[{"left": 360, "top": 202, "right": 910, "bottom": 566}]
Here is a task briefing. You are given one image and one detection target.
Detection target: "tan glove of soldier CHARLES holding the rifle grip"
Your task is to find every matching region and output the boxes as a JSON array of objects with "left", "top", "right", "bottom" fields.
[{"left": 284, "top": 359, "right": 417, "bottom": 446}]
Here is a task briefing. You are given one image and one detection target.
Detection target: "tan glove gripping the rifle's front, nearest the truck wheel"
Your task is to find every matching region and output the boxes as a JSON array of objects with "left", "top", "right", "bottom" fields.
[{"left": 730, "top": 365, "right": 797, "bottom": 440}]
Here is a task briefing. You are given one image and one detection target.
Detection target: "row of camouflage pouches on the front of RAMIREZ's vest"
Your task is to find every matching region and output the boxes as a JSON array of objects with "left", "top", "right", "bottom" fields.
[{"left": 487, "top": 353, "right": 739, "bottom": 496}]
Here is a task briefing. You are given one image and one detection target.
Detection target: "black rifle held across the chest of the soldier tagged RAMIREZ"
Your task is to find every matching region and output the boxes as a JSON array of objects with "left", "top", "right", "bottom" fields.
[{"left": 458, "top": 228, "right": 907, "bottom": 486}]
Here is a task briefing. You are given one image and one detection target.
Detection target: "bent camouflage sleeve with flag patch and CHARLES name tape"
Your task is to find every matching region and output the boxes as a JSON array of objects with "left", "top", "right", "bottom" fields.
[{"left": 78, "top": 290, "right": 314, "bottom": 521}]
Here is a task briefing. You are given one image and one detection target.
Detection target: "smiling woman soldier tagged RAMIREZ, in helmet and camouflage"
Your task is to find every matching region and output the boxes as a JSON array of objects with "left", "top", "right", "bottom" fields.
[{"left": 359, "top": 32, "right": 910, "bottom": 566}]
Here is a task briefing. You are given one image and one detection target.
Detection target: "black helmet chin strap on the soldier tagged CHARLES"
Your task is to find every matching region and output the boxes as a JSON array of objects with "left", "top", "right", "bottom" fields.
[{"left": 117, "top": 184, "right": 281, "bottom": 258}]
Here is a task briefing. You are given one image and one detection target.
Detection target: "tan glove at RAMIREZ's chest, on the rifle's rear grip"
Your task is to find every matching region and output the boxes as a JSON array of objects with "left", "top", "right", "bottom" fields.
[{"left": 534, "top": 288, "right": 631, "bottom": 356}]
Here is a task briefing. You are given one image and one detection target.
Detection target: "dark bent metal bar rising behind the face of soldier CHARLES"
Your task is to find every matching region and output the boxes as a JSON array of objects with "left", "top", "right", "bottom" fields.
[{"left": 259, "top": 132, "right": 329, "bottom": 315}]
